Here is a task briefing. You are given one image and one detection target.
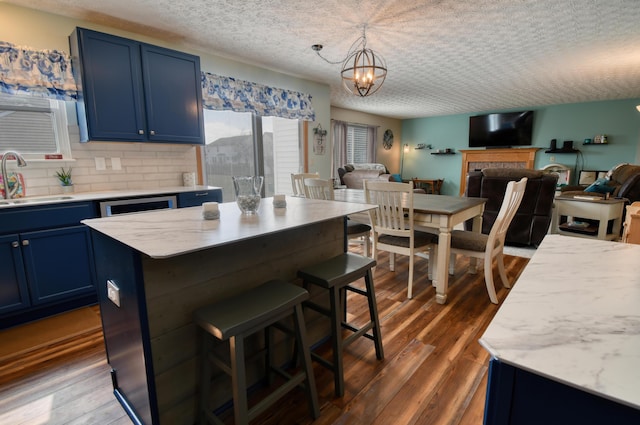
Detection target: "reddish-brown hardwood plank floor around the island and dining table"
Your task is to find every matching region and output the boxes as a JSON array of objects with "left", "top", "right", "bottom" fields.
[{"left": 0, "top": 248, "right": 528, "bottom": 425}]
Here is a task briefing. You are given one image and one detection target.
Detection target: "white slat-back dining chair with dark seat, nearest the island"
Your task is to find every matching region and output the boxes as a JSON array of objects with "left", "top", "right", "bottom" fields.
[{"left": 364, "top": 180, "right": 438, "bottom": 298}]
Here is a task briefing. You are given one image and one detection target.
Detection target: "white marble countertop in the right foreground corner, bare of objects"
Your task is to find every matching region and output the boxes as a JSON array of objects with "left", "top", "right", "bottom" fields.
[{"left": 480, "top": 235, "right": 640, "bottom": 409}]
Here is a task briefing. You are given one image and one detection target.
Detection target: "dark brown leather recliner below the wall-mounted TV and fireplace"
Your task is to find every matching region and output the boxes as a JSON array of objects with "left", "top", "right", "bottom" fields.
[{"left": 465, "top": 168, "right": 558, "bottom": 247}]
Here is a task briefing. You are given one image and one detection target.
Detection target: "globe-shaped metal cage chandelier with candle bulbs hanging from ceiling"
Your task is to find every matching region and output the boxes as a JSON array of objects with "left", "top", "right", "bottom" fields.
[{"left": 311, "top": 25, "right": 387, "bottom": 97}]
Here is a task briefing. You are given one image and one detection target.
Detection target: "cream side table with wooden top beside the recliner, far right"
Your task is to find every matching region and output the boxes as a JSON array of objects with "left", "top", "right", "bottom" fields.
[{"left": 553, "top": 196, "right": 624, "bottom": 240}]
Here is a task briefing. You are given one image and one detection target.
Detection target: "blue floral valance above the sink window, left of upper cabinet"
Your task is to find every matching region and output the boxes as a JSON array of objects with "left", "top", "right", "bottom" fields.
[{"left": 0, "top": 41, "right": 78, "bottom": 100}]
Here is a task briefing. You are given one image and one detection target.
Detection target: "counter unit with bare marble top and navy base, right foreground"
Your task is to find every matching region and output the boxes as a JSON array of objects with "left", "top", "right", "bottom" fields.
[{"left": 480, "top": 235, "right": 640, "bottom": 425}]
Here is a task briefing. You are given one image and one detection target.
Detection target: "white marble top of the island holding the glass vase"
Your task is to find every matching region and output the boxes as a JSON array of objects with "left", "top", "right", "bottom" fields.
[{"left": 82, "top": 196, "right": 376, "bottom": 258}]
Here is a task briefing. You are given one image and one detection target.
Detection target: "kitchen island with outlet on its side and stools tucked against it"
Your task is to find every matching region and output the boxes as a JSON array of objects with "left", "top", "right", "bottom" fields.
[{"left": 83, "top": 197, "right": 373, "bottom": 425}]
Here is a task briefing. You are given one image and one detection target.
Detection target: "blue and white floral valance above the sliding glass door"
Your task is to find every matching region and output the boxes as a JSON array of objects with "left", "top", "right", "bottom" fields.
[{"left": 202, "top": 72, "right": 316, "bottom": 121}]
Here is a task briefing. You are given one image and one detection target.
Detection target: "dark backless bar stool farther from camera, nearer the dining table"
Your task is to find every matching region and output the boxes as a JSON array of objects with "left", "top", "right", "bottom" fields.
[{"left": 298, "top": 252, "right": 384, "bottom": 397}]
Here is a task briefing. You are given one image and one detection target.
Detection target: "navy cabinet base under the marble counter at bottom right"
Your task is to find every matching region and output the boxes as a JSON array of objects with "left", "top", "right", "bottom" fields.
[{"left": 484, "top": 359, "right": 640, "bottom": 425}]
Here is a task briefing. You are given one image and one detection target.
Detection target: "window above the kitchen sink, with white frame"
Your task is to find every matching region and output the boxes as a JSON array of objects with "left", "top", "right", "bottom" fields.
[{"left": 0, "top": 94, "right": 71, "bottom": 159}]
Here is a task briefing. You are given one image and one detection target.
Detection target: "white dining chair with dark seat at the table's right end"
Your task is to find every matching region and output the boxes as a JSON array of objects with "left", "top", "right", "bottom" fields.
[{"left": 449, "top": 177, "right": 527, "bottom": 304}]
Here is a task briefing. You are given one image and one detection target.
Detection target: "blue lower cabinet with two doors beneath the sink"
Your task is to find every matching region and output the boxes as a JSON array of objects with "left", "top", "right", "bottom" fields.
[{"left": 0, "top": 202, "right": 98, "bottom": 329}]
